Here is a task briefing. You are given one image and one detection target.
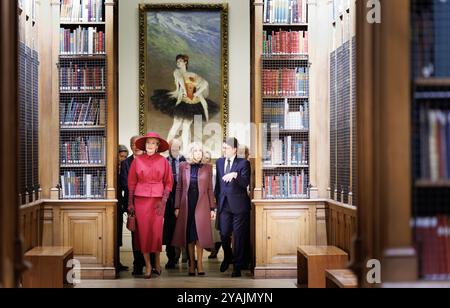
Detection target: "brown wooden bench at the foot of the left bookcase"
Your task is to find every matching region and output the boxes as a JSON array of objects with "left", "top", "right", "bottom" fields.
[{"left": 23, "top": 247, "right": 73, "bottom": 288}]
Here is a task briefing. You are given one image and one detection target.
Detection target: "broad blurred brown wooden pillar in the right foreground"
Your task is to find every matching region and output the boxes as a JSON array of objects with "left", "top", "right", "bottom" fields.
[{"left": 352, "top": 0, "right": 417, "bottom": 287}]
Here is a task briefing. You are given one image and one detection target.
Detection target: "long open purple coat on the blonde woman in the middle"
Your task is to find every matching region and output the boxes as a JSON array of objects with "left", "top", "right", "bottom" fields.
[{"left": 172, "top": 163, "right": 216, "bottom": 248}]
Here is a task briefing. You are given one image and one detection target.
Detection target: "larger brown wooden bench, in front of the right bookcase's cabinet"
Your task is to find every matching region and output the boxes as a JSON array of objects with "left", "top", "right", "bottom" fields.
[{"left": 297, "top": 246, "right": 348, "bottom": 288}]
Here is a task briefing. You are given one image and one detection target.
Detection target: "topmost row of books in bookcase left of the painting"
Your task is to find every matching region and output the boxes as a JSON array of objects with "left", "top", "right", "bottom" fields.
[{"left": 61, "top": 0, "right": 104, "bottom": 22}]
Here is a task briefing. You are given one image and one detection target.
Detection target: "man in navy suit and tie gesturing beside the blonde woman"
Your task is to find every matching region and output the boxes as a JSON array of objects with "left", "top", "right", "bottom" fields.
[{"left": 216, "top": 138, "right": 251, "bottom": 277}]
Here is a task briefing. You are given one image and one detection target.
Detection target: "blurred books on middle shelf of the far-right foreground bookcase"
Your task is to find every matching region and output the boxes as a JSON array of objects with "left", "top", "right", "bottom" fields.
[{"left": 420, "top": 108, "right": 450, "bottom": 181}]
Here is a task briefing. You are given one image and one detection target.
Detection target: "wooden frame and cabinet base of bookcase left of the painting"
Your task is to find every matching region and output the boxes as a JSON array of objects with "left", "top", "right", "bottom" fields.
[{"left": 34, "top": 0, "right": 118, "bottom": 279}]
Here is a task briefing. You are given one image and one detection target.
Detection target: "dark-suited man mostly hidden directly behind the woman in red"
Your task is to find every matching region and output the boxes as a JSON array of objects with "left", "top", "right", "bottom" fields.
[{"left": 119, "top": 136, "right": 154, "bottom": 276}]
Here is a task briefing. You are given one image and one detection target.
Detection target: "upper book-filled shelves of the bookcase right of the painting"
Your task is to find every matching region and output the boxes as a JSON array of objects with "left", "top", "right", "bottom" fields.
[{"left": 254, "top": 0, "right": 311, "bottom": 198}]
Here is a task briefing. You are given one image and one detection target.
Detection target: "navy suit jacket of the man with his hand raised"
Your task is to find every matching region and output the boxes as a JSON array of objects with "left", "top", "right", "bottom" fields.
[{"left": 215, "top": 158, "right": 251, "bottom": 214}]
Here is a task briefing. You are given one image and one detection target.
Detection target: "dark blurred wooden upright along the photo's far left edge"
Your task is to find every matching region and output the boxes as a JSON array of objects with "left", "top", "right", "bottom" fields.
[{"left": 0, "top": 1, "right": 22, "bottom": 288}]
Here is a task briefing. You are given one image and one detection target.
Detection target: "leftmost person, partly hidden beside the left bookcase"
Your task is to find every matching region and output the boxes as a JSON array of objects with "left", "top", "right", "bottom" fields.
[{"left": 116, "top": 145, "right": 129, "bottom": 273}]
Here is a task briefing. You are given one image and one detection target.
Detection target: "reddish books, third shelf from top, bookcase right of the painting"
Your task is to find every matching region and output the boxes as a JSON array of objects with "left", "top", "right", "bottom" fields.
[{"left": 262, "top": 67, "right": 309, "bottom": 96}]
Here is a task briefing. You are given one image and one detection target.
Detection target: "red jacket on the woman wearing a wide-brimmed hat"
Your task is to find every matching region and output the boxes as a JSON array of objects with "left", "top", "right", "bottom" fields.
[{"left": 128, "top": 154, "right": 173, "bottom": 201}]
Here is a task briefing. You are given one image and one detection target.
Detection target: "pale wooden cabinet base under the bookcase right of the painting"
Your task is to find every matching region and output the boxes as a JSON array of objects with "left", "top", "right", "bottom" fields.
[{"left": 253, "top": 200, "right": 326, "bottom": 278}]
